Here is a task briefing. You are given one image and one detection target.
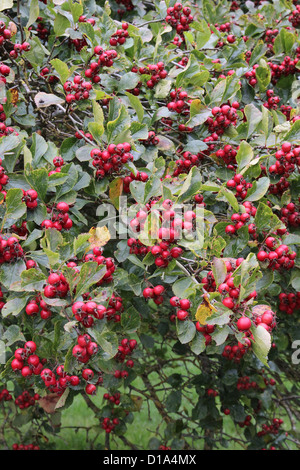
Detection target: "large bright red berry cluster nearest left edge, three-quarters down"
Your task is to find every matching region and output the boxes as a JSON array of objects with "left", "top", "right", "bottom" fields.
[{"left": 11, "top": 341, "right": 45, "bottom": 377}]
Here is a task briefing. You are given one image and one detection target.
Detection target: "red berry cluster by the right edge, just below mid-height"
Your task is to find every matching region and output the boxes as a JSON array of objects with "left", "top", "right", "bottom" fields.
[{"left": 257, "top": 237, "right": 297, "bottom": 271}]
